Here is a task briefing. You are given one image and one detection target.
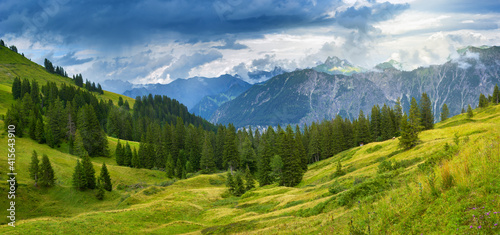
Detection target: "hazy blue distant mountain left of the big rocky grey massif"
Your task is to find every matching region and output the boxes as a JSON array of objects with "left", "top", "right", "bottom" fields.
[{"left": 123, "top": 74, "right": 249, "bottom": 109}]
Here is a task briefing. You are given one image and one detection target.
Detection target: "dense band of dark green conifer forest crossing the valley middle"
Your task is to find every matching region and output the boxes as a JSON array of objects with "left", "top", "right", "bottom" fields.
[{"left": 5, "top": 74, "right": 499, "bottom": 191}]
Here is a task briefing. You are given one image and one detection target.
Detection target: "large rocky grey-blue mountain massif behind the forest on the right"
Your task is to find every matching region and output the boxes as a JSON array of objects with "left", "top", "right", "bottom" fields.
[{"left": 211, "top": 47, "right": 500, "bottom": 127}]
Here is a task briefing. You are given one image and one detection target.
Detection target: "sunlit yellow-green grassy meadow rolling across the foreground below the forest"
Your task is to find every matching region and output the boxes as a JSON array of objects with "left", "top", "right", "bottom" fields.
[{"left": 0, "top": 103, "right": 500, "bottom": 234}]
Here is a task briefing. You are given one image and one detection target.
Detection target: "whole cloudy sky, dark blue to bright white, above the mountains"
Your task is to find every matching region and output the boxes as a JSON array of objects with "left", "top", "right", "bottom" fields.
[{"left": 0, "top": 0, "right": 500, "bottom": 86}]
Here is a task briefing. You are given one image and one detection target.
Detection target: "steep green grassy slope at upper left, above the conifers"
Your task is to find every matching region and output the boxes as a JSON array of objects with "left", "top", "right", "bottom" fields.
[{"left": 0, "top": 46, "right": 135, "bottom": 114}]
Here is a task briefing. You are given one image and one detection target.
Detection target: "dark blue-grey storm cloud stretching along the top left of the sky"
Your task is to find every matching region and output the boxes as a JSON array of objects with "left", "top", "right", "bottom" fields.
[{"left": 0, "top": 0, "right": 341, "bottom": 47}]
